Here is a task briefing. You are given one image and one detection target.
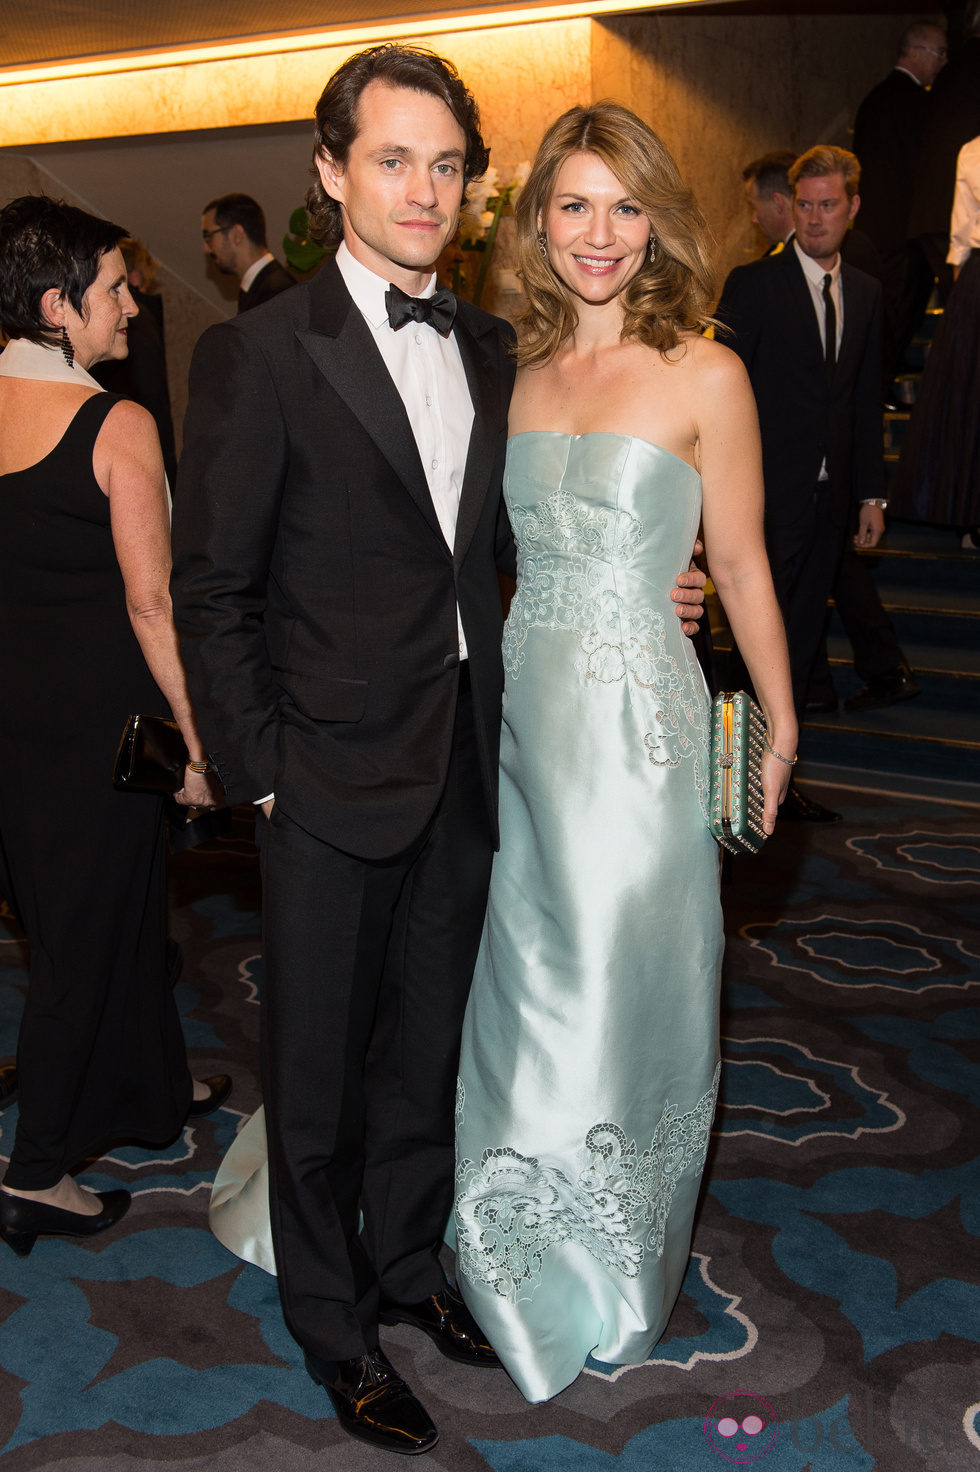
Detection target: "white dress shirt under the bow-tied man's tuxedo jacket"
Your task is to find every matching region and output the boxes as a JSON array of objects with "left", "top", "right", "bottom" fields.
[{"left": 337, "top": 244, "right": 474, "bottom": 659}]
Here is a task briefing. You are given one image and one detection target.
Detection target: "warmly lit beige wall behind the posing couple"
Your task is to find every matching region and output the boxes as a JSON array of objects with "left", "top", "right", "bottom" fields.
[{"left": 0, "top": 12, "right": 924, "bottom": 425}]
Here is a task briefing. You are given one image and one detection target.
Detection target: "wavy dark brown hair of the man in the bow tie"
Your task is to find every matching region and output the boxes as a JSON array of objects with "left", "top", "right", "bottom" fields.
[{"left": 306, "top": 41, "right": 490, "bottom": 247}]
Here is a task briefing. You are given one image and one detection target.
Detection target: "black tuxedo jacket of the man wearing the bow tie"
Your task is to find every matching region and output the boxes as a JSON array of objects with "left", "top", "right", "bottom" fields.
[{"left": 172, "top": 261, "right": 514, "bottom": 858}]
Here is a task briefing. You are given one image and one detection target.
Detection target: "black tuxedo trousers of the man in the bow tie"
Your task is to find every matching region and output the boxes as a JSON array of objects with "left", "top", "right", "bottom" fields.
[{"left": 259, "top": 665, "right": 493, "bottom": 1360}]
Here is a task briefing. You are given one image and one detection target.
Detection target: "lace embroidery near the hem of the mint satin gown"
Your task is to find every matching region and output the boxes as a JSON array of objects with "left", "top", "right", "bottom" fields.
[{"left": 455, "top": 1064, "right": 721, "bottom": 1301}]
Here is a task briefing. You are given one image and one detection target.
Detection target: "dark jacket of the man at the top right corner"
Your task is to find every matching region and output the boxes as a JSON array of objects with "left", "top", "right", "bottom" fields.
[{"left": 853, "top": 68, "right": 928, "bottom": 250}]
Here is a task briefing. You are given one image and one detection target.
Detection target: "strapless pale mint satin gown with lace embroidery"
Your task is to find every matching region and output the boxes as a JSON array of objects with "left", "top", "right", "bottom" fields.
[{"left": 455, "top": 433, "right": 722, "bottom": 1400}]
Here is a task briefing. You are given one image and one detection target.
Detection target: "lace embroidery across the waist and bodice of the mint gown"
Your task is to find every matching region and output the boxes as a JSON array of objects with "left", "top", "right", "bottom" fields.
[{"left": 503, "top": 490, "right": 709, "bottom": 821}]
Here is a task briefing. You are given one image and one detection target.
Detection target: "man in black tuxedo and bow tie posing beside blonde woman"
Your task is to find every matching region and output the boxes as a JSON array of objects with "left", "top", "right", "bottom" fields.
[{"left": 174, "top": 44, "right": 703, "bottom": 1453}]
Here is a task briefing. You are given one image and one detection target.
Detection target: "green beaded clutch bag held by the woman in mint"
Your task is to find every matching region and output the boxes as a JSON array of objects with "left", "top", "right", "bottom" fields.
[{"left": 708, "top": 690, "right": 768, "bottom": 854}]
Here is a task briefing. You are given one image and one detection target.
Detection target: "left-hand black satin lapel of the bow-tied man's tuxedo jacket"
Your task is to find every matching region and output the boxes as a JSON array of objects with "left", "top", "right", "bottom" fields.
[{"left": 296, "top": 261, "right": 446, "bottom": 546}]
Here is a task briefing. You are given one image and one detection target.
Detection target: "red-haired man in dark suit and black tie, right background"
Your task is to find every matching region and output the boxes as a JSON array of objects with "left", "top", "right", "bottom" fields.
[{"left": 718, "top": 146, "right": 884, "bottom": 821}]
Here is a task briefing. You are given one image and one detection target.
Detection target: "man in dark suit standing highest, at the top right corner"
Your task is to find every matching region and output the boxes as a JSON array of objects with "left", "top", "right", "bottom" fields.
[{"left": 853, "top": 21, "right": 946, "bottom": 377}]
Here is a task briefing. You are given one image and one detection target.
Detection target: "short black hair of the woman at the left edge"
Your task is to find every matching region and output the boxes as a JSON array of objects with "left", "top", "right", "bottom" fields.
[{"left": 0, "top": 194, "right": 129, "bottom": 347}]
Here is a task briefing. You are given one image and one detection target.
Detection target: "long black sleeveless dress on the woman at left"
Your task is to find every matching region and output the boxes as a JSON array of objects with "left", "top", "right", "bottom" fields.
[{"left": 0, "top": 393, "right": 191, "bottom": 1191}]
